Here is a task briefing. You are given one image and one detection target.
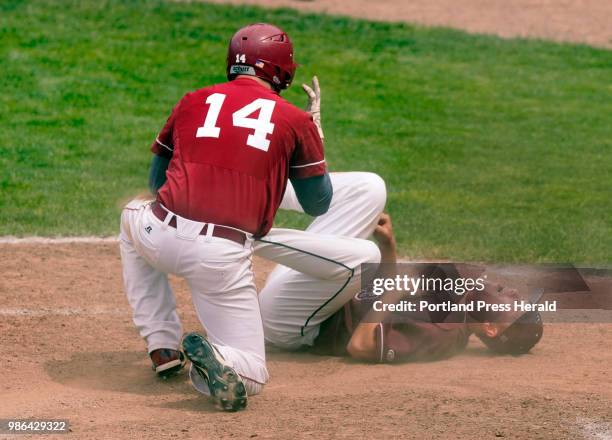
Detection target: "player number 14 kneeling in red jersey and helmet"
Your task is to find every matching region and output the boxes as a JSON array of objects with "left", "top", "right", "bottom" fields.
[{"left": 120, "top": 24, "right": 380, "bottom": 410}]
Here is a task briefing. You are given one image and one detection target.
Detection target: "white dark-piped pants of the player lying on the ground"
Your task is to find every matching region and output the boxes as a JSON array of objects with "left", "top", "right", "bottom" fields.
[{"left": 255, "top": 172, "right": 387, "bottom": 350}]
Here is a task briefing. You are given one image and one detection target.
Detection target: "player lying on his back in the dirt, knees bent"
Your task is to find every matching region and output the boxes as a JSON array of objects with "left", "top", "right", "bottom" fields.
[{"left": 255, "top": 78, "right": 542, "bottom": 360}]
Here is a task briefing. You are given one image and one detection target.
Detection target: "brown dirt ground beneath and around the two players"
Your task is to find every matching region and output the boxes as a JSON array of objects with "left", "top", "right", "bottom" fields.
[{"left": 0, "top": 243, "right": 612, "bottom": 439}]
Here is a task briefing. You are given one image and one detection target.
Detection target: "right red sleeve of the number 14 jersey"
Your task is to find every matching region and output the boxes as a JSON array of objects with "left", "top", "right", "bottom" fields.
[{"left": 289, "top": 115, "right": 327, "bottom": 179}]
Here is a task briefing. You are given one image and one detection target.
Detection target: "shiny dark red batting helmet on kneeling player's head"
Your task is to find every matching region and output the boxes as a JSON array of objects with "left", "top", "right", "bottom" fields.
[{"left": 227, "top": 23, "right": 297, "bottom": 91}]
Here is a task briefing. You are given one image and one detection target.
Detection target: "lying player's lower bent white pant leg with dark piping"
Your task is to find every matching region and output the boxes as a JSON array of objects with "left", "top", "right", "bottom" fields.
[{"left": 255, "top": 229, "right": 380, "bottom": 349}]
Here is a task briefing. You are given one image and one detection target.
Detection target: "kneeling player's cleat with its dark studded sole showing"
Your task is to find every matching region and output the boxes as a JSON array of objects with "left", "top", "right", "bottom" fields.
[{"left": 183, "top": 333, "right": 247, "bottom": 411}]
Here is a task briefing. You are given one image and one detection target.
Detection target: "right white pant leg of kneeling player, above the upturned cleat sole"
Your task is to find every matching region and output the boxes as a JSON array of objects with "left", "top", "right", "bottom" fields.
[{"left": 152, "top": 208, "right": 268, "bottom": 395}]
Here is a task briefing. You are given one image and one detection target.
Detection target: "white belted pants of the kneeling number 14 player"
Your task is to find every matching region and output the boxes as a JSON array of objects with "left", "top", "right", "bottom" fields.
[{"left": 120, "top": 200, "right": 268, "bottom": 395}]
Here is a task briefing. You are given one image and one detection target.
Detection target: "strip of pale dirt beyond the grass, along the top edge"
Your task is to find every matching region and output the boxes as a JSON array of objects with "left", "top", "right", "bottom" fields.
[{"left": 201, "top": 0, "right": 612, "bottom": 48}]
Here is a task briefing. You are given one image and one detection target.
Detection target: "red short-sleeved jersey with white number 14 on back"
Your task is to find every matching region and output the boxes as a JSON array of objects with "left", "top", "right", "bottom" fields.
[{"left": 151, "top": 78, "right": 326, "bottom": 237}]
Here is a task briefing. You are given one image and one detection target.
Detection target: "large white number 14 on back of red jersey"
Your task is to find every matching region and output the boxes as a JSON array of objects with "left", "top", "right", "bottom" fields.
[{"left": 196, "top": 93, "right": 276, "bottom": 151}]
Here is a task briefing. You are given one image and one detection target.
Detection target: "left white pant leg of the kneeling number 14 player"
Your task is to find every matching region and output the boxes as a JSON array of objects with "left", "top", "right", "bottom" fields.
[{"left": 119, "top": 201, "right": 183, "bottom": 353}]
